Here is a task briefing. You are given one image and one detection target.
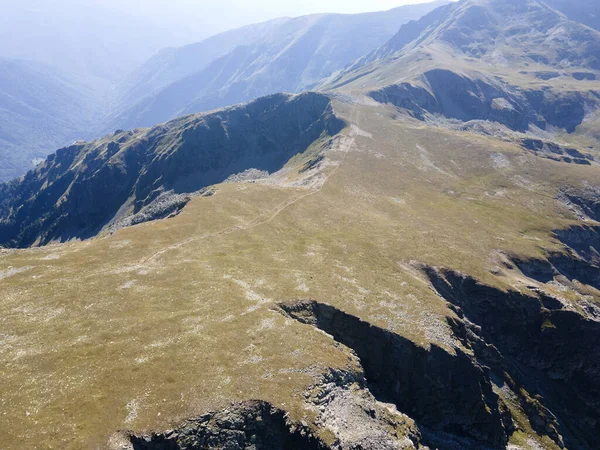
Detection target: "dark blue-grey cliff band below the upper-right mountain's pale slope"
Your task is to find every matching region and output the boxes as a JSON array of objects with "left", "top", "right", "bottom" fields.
[{"left": 370, "top": 69, "right": 600, "bottom": 132}]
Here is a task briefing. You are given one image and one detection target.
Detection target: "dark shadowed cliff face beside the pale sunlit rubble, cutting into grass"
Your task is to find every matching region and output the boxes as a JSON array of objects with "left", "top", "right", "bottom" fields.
[{"left": 281, "top": 301, "right": 510, "bottom": 448}]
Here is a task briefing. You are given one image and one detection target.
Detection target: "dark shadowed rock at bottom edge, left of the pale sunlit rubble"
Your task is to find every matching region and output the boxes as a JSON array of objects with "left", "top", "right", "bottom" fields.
[{"left": 129, "top": 401, "right": 328, "bottom": 450}]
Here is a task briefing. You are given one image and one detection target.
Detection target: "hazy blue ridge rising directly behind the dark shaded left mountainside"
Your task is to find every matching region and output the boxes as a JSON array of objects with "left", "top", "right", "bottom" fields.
[{"left": 110, "top": 1, "right": 447, "bottom": 128}]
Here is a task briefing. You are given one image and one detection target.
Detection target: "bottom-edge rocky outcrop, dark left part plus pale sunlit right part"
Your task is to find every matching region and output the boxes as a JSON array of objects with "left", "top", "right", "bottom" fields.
[{"left": 123, "top": 369, "right": 422, "bottom": 450}]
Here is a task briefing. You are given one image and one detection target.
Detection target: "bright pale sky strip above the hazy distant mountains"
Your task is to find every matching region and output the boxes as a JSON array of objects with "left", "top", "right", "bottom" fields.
[{"left": 0, "top": 0, "right": 446, "bottom": 45}]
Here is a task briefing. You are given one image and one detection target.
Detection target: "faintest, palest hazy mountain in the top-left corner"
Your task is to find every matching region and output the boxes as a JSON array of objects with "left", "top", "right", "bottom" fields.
[{"left": 0, "top": 0, "right": 177, "bottom": 84}]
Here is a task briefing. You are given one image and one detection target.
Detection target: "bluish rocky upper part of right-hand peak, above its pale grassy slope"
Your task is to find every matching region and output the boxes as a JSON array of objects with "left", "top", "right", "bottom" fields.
[{"left": 355, "top": 0, "right": 600, "bottom": 70}]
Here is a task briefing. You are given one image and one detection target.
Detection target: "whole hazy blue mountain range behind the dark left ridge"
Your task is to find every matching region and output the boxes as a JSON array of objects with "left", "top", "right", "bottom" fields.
[{"left": 0, "top": 2, "right": 440, "bottom": 181}]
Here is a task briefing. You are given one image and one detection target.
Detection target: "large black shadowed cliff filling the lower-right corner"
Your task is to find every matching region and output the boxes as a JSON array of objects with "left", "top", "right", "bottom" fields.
[{"left": 425, "top": 268, "right": 600, "bottom": 449}]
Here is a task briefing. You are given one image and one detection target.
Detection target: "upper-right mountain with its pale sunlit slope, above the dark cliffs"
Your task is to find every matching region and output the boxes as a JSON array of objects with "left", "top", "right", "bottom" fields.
[{"left": 322, "top": 0, "right": 600, "bottom": 97}]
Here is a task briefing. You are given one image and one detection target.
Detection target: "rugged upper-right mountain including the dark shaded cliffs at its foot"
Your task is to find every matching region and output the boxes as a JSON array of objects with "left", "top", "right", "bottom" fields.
[{"left": 321, "top": 0, "right": 600, "bottom": 133}]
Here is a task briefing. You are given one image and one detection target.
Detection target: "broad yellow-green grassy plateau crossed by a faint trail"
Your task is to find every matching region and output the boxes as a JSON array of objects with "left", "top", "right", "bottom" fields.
[{"left": 0, "top": 97, "right": 600, "bottom": 449}]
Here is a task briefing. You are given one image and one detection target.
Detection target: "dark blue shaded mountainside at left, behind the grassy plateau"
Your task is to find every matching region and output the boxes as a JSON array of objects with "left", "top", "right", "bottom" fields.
[{"left": 0, "top": 93, "right": 343, "bottom": 247}]
